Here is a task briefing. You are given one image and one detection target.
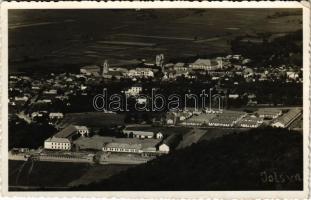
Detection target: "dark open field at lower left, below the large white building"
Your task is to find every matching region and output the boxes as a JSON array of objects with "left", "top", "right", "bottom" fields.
[{"left": 9, "top": 161, "right": 131, "bottom": 190}]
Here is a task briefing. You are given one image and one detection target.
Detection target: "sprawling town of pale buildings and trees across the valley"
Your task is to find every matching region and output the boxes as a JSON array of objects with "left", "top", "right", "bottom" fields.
[{"left": 9, "top": 54, "right": 303, "bottom": 164}]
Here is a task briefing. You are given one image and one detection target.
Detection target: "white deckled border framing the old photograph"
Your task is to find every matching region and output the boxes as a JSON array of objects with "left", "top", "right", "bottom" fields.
[{"left": 0, "top": 1, "right": 311, "bottom": 199}]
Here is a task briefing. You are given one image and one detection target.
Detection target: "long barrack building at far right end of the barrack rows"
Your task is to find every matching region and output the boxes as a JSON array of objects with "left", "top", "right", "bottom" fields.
[{"left": 272, "top": 108, "right": 302, "bottom": 128}]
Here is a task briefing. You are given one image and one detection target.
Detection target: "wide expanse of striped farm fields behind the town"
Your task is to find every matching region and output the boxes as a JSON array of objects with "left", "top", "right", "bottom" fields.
[{"left": 9, "top": 9, "right": 301, "bottom": 73}]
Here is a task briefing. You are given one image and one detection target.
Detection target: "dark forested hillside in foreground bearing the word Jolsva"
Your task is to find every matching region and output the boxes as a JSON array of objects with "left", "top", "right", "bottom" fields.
[{"left": 73, "top": 128, "right": 303, "bottom": 191}]
